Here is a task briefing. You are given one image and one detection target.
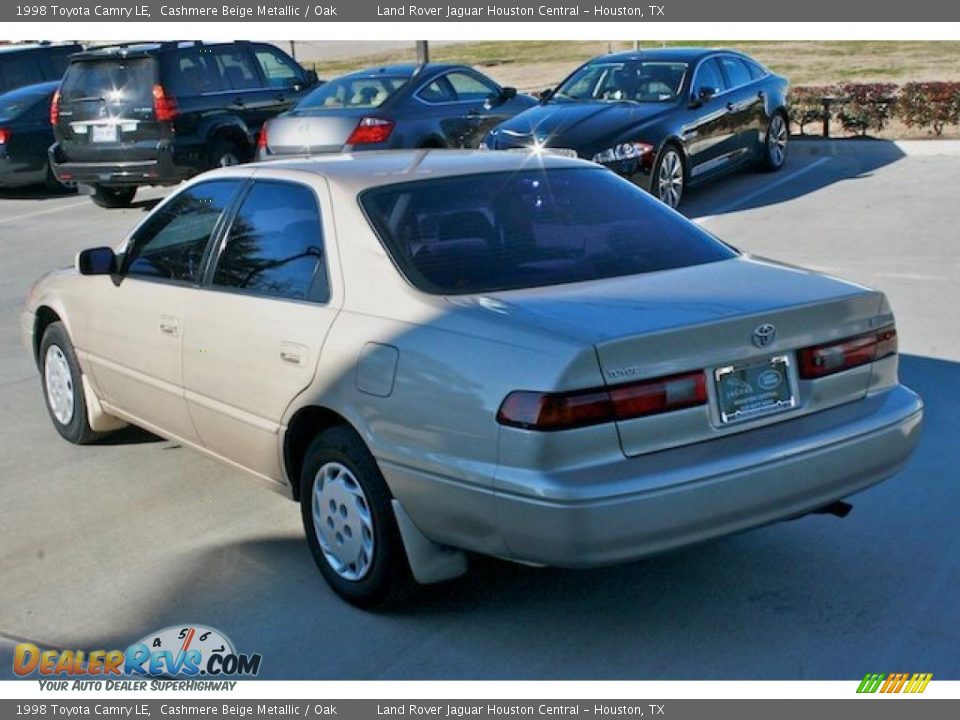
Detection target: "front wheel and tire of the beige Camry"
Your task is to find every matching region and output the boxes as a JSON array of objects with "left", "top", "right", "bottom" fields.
[{"left": 40, "top": 322, "right": 102, "bottom": 445}]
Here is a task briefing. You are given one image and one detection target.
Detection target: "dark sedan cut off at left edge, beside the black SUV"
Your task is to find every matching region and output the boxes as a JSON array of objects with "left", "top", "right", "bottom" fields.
[{"left": 0, "top": 81, "right": 63, "bottom": 190}]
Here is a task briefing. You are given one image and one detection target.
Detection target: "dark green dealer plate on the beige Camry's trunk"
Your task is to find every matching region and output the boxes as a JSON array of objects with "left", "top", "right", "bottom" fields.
[{"left": 714, "top": 355, "right": 797, "bottom": 423}]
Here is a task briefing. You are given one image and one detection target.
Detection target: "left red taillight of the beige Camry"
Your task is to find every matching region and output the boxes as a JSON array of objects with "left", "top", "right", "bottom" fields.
[{"left": 497, "top": 370, "right": 707, "bottom": 430}]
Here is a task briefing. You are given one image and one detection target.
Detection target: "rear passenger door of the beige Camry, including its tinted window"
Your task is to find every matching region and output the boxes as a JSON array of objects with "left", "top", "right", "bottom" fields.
[{"left": 183, "top": 176, "right": 341, "bottom": 480}]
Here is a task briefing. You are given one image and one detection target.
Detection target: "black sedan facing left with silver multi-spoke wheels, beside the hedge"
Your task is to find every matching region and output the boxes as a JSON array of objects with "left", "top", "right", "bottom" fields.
[{"left": 484, "top": 48, "right": 789, "bottom": 208}]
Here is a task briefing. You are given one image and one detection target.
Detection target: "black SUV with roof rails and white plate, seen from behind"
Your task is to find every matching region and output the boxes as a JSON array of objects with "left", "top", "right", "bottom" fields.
[{"left": 50, "top": 41, "right": 317, "bottom": 207}]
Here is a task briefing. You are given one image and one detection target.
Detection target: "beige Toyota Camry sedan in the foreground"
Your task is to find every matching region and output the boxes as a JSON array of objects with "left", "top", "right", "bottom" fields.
[{"left": 22, "top": 150, "right": 923, "bottom": 605}]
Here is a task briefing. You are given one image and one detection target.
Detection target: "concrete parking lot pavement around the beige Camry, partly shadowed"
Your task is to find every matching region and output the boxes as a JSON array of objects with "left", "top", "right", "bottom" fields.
[{"left": 0, "top": 142, "right": 960, "bottom": 680}]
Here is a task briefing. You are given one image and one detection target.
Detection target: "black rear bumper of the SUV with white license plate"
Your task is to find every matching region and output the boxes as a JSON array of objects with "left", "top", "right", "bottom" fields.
[{"left": 49, "top": 142, "right": 197, "bottom": 187}]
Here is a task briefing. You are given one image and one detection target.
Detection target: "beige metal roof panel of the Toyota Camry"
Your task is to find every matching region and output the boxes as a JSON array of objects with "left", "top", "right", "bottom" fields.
[{"left": 249, "top": 149, "right": 597, "bottom": 192}]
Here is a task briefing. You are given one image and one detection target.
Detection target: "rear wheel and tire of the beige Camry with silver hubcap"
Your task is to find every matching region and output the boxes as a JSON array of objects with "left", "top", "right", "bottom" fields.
[{"left": 300, "top": 427, "right": 416, "bottom": 608}]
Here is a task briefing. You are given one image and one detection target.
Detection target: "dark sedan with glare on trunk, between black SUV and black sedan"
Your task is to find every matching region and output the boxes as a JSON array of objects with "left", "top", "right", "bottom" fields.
[{"left": 259, "top": 63, "right": 537, "bottom": 159}]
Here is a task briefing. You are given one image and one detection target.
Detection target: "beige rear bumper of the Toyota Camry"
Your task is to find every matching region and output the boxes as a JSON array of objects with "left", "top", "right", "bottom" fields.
[{"left": 495, "top": 386, "right": 923, "bottom": 567}]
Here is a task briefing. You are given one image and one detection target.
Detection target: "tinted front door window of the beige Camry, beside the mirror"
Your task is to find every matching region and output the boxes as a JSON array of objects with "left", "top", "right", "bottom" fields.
[{"left": 124, "top": 180, "right": 241, "bottom": 283}]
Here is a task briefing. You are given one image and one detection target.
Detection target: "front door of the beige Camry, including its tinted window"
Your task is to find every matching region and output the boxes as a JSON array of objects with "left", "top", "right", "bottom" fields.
[{"left": 85, "top": 180, "right": 242, "bottom": 442}]
